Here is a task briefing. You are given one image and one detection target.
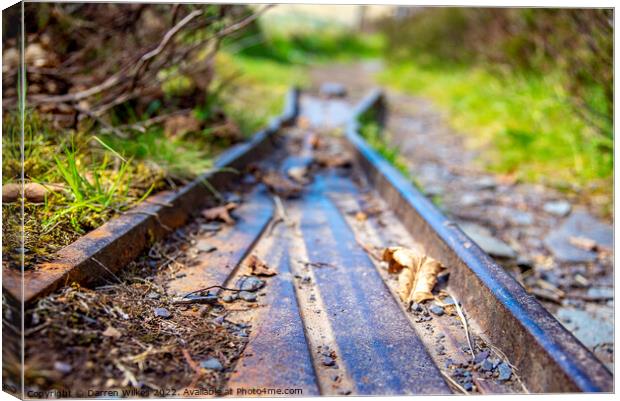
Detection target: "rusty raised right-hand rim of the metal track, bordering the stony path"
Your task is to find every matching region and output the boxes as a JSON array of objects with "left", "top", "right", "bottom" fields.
[{"left": 346, "top": 91, "right": 613, "bottom": 392}]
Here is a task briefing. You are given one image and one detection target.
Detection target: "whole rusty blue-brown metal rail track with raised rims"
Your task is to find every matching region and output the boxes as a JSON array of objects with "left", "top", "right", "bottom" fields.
[{"left": 3, "top": 86, "right": 613, "bottom": 395}]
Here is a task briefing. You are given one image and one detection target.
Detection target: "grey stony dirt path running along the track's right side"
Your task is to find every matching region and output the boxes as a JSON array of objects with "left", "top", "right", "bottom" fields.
[{"left": 312, "top": 62, "right": 614, "bottom": 371}]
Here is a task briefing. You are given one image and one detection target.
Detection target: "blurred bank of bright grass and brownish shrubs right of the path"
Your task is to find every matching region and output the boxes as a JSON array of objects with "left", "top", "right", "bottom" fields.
[{"left": 379, "top": 8, "right": 613, "bottom": 192}]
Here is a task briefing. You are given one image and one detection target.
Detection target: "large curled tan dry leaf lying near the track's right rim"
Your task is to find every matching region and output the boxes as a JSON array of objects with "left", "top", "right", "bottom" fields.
[{"left": 383, "top": 246, "right": 442, "bottom": 304}]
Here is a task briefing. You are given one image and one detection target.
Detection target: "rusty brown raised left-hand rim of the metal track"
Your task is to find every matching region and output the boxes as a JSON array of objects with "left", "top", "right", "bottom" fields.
[{"left": 3, "top": 89, "right": 299, "bottom": 303}]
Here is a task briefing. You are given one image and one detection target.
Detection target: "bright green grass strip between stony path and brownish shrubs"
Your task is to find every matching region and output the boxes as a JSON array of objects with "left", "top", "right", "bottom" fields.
[{"left": 380, "top": 62, "right": 613, "bottom": 191}]
